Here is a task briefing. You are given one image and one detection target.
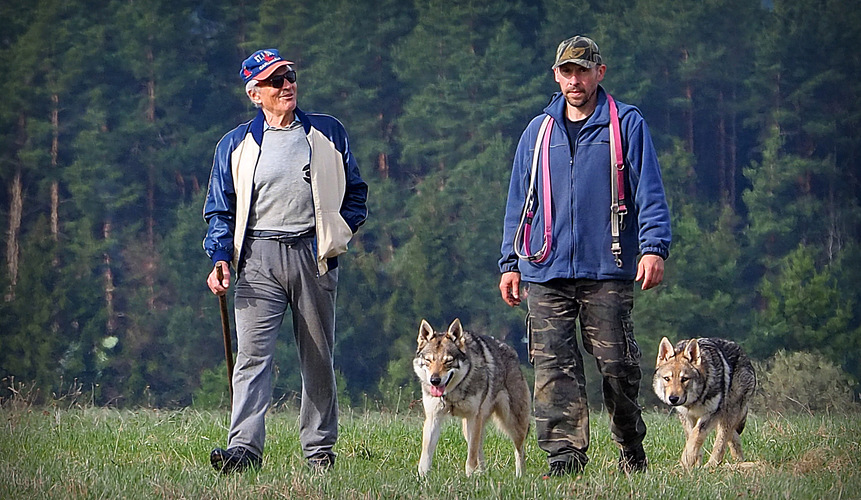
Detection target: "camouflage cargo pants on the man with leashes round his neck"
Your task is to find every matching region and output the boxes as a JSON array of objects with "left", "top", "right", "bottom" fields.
[{"left": 527, "top": 279, "right": 646, "bottom": 465}]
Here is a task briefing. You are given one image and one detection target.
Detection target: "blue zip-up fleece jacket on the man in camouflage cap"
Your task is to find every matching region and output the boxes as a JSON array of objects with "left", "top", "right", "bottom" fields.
[{"left": 499, "top": 86, "right": 671, "bottom": 283}]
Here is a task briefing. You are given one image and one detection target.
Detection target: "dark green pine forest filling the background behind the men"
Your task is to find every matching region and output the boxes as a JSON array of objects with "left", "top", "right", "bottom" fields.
[{"left": 0, "top": 0, "right": 861, "bottom": 407}]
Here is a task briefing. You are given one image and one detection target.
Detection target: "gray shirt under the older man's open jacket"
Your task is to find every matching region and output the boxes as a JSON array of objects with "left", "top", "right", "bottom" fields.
[{"left": 248, "top": 120, "right": 314, "bottom": 234}]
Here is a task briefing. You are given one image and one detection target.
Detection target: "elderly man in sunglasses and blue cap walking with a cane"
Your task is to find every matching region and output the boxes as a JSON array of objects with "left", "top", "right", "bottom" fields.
[{"left": 203, "top": 49, "right": 368, "bottom": 474}]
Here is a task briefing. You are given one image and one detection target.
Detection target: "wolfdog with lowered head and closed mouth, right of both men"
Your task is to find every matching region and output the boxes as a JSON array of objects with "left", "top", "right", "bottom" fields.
[{"left": 652, "top": 337, "right": 756, "bottom": 468}]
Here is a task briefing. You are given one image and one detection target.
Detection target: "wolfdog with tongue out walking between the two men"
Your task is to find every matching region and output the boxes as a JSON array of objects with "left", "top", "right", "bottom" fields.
[{"left": 413, "top": 319, "right": 531, "bottom": 476}]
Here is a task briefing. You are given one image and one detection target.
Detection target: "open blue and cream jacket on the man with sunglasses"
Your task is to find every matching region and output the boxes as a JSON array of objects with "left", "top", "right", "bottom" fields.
[{"left": 203, "top": 108, "right": 368, "bottom": 276}]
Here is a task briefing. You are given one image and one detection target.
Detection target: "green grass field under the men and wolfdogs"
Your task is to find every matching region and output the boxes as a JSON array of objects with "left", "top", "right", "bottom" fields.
[{"left": 0, "top": 405, "right": 861, "bottom": 499}]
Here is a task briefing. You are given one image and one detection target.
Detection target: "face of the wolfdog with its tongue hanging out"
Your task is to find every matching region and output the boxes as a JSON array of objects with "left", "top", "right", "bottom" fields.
[{"left": 413, "top": 335, "right": 468, "bottom": 397}]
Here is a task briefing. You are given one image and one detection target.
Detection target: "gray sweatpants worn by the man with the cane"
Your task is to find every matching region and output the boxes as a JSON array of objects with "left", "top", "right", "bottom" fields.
[{"left": 228, "top": 236, "right": 338, "bottom": 458}]
